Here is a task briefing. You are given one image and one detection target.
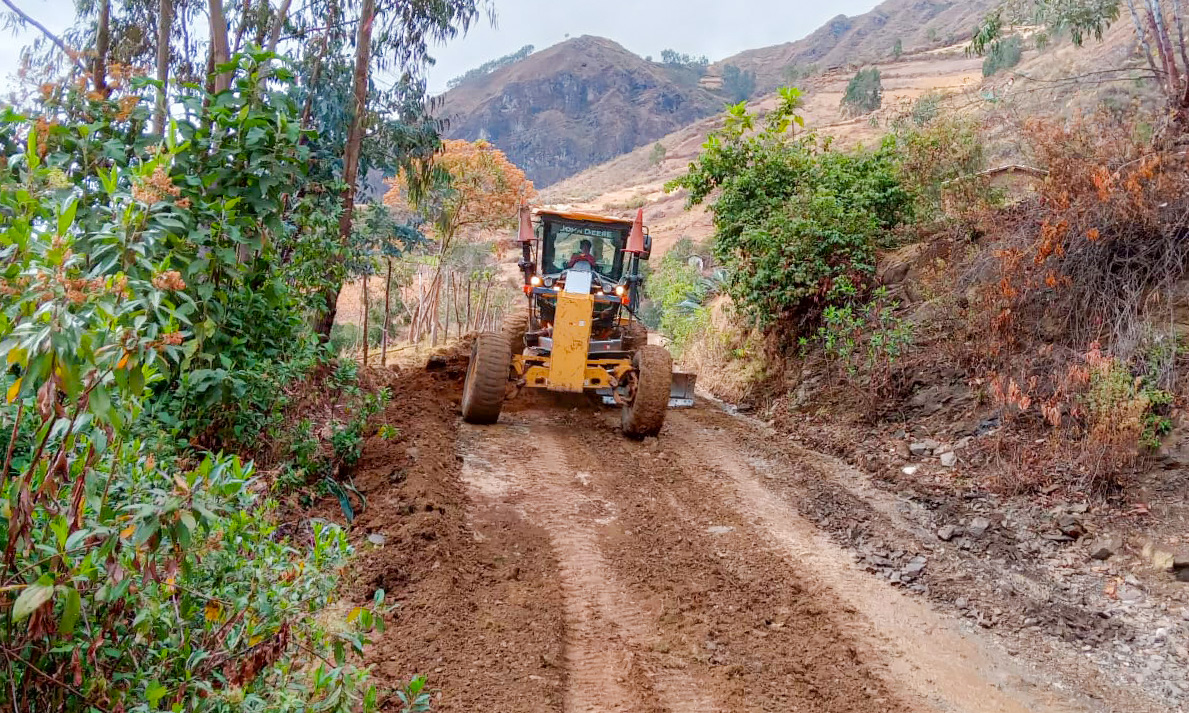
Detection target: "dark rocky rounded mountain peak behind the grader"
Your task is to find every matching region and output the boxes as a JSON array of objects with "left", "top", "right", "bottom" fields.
[{"left": 439, "top": 37, "right": 724, "bottom": 187}]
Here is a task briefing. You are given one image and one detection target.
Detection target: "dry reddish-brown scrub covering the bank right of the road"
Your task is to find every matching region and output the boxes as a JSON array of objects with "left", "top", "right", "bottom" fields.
[{"left": 661, "top": 87, "right": 1189, "bottom": 492}]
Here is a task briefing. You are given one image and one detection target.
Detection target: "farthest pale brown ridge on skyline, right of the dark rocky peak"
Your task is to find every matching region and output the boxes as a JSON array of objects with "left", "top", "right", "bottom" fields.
[{"left": 711, "top": 0, "right": 1001, "bottom": 92}]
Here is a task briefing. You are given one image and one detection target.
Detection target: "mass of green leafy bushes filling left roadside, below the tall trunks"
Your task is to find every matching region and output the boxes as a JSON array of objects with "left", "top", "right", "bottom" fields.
[{"left": 0, "top": 79, "right": 387, "bottom": 711}]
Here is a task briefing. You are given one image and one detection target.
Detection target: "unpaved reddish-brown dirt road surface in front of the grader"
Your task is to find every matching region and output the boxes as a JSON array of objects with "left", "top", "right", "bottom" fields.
[{"left": 347, "top": 370, "right": 1163, "bottom": 713}]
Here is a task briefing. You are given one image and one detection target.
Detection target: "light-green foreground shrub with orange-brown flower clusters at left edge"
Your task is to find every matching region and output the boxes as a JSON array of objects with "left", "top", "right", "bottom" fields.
[{"left": 0, "top": 126, "right": 376, "bottom": 713}]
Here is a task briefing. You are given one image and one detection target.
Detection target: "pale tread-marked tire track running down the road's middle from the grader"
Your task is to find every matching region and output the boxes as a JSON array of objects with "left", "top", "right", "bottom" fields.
[{"left": 460, "top": 415, "right": 721, "bottom": 713}]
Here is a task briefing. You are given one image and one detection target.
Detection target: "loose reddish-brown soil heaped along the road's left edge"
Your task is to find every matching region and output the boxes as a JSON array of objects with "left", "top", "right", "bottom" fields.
[{"left": 328, "top": 359, "right": 562, "bottom": 713}]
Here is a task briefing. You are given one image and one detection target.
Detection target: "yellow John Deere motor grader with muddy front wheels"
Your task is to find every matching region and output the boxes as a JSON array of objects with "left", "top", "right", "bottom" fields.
[{"left": 463, "top": 206, "right": 694, "bottom": 438}]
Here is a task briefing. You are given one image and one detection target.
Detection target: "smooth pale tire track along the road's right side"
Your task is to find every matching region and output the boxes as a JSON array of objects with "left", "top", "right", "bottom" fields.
[{"left": 665, "top": 411, "right": 1101, "bottom": 713}]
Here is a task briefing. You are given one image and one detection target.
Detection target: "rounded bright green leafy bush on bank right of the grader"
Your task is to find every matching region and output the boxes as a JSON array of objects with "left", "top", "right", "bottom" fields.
[{"left": 668, "top": 89, "right": 913, "bottom": 332}]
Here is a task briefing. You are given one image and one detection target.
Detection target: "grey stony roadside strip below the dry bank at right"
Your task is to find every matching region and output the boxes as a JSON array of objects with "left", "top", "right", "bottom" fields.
[{"left": 737, "top": 404, "right": 1189, "bottom": 709}]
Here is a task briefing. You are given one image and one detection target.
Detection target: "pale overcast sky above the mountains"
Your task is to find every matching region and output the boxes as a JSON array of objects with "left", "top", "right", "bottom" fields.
[{"left": 0, "top": 0, "right": 877, "bottom": 93}]
